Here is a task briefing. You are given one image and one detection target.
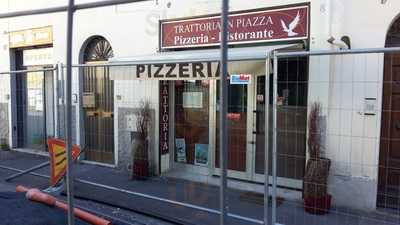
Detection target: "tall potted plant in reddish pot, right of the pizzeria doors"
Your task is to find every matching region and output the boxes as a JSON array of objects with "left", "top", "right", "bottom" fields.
[{"left": 304, "top": 102, "right": 332, "bottom": 214}]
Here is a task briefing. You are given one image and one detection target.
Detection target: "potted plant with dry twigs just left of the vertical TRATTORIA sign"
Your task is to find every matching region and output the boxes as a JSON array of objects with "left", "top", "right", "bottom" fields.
[{"left": 132, "top": 100, "right": 151, "bottom": 179}]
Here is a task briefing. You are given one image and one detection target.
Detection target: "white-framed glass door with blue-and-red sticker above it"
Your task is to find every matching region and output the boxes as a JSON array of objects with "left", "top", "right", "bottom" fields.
[{"left": 215, "top": 60, "right": 265, "bottom": 180}]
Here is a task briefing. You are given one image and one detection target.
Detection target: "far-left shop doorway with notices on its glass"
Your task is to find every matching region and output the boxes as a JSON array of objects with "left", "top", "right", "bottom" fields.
[{"left": 15, "top": 48, "right": 55, "bottom": 151}]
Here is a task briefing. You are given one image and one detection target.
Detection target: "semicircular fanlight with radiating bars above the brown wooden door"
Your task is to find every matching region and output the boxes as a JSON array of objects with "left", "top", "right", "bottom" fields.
[{"left": 83, "top": 36, "right": 114, "bottom": 62}]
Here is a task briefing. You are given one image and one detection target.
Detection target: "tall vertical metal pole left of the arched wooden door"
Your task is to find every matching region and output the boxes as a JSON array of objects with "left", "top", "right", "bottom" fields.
[{"left": 65, "top": 0, "right": 75, "bottom": 225}]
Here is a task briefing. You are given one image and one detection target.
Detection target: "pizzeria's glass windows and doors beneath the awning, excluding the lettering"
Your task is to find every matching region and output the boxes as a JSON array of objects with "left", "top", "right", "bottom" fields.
[{"left": 173, "top": 59, "right": 307, "bottom": 189}]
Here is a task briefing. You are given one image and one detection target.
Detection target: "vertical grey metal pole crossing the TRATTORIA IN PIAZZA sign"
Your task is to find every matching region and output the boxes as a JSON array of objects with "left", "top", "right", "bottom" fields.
[{"left": 219, "top": 0, "right": 229, "bottom": 225}]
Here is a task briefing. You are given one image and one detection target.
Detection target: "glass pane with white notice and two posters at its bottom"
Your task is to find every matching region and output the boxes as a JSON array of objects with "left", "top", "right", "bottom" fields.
[{"left": 175, "top": 81, "right": 209, "bottom": 166}]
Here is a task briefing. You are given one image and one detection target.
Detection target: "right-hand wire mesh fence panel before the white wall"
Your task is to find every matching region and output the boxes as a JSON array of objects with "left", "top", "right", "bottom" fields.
[{"left": 272, "top": 48, "right": 399, "bottom": 224}]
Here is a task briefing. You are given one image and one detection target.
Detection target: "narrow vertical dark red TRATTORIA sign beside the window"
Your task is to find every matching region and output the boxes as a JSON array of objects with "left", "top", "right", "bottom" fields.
[{"left": 159, "top": 81, "right": 169, "bottom": 154}]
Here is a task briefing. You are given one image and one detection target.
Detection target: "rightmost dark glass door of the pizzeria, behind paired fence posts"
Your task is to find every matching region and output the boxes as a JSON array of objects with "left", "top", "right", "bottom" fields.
[{"left": 253, "top": 58, "right": 307, "bottom": 189}]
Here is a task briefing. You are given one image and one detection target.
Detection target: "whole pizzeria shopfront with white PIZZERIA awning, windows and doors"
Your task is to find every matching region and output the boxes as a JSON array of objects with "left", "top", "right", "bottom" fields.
[{"left": 110, "top": 44, "right": 308, "bottom": 189}]
